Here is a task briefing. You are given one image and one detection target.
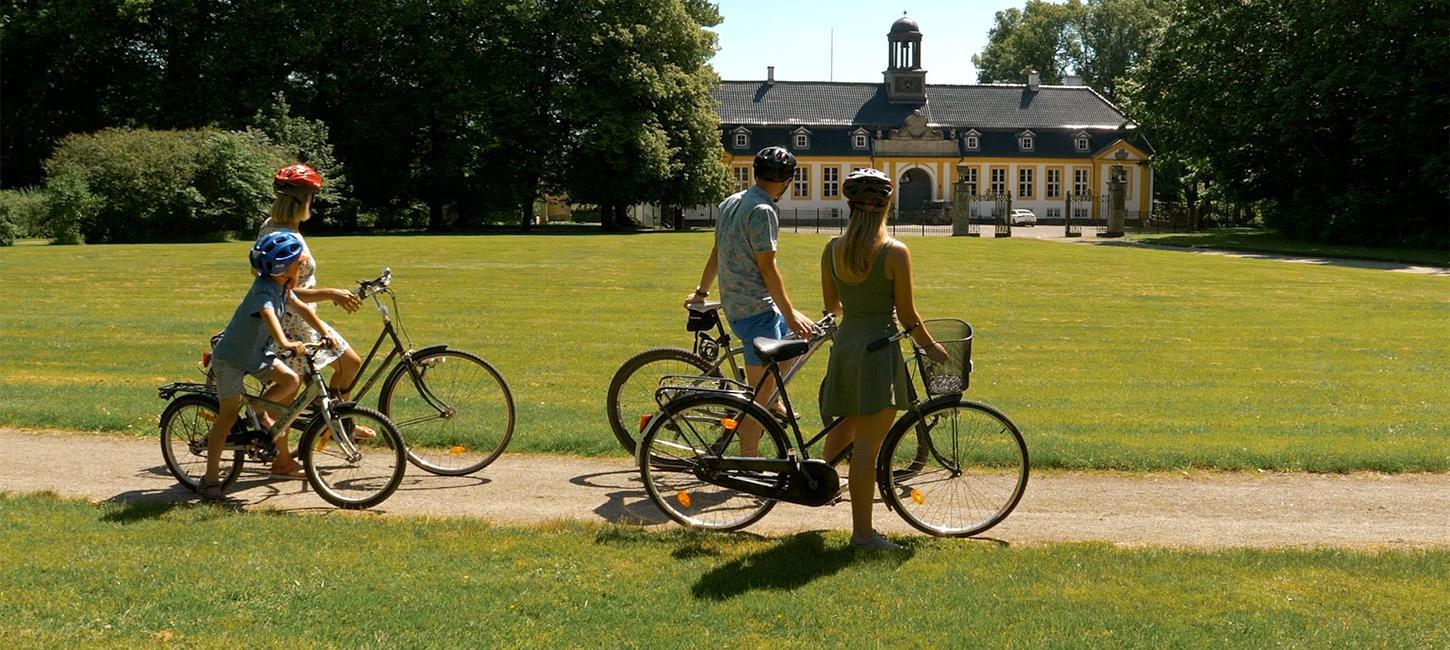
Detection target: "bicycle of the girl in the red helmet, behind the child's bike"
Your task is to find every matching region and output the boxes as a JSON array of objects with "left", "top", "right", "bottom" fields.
[{"left": 329, "top": 267, "right": 515, "bottom": 476}]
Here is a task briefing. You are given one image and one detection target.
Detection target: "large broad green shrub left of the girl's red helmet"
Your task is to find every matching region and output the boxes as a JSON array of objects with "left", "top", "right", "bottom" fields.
[{"left": 45, "top": 129, "right": 287, "bottom": 242}]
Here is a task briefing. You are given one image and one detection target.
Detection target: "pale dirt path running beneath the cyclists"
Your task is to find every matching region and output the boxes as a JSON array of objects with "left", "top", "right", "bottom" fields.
[{"left": 0, "top": 428, "right": 1450, "bottom": 548}]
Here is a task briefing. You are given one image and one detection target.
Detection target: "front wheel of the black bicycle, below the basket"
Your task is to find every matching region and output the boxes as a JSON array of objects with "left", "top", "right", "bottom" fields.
[{"left": 876, "top": 396, "right": 1028, "bottom": 537}]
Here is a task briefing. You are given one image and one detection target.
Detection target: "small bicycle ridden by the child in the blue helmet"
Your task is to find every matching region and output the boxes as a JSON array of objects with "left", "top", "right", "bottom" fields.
[{"left": 157, "top": 345, "right": 407, "bottom": 509}]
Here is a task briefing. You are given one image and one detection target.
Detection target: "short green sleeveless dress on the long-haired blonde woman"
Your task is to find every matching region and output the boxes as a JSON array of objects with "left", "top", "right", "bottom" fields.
[{"left": 821, "top": 239, "right": 909, "bottom": 418}]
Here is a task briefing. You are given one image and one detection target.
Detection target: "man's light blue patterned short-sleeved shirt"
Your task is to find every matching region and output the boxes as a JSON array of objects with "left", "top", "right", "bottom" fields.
[{"left": 715, "top": 186, "right": 780, "bottom": 321}]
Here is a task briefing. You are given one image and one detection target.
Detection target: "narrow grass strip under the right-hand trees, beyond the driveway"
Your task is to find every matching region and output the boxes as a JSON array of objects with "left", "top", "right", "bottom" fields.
[{"left": 1128, "top": 228, "right": 1450, "bottom": 267}]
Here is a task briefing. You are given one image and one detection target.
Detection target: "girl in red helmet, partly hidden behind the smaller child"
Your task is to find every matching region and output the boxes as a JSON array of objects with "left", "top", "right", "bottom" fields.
[{"left": 258, "top": 164, "right": 374, "bottom": 435}]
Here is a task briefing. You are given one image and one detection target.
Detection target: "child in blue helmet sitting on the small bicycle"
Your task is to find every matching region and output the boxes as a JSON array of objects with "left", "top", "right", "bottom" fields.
[{"left": 200, "top": 232, "right": 339, "bottom": 501}]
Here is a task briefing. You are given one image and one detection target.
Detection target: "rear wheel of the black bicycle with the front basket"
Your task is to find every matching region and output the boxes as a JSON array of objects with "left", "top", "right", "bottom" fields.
[{"left": 635, "top": 395, "right": 787, "bottom": 531}]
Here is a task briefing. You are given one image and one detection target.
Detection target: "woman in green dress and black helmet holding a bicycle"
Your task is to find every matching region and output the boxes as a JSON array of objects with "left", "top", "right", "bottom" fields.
[{"left": 821, "top": 168, "right": 947, "bottom": 550}]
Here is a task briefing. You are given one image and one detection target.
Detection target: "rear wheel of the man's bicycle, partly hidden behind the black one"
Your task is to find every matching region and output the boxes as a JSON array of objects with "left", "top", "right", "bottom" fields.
[{"left": 605, "top": 348, "right": 724, "bottom": 456}]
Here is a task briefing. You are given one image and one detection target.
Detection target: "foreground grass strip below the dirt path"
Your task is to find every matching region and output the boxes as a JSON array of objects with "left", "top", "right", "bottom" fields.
[{"left": 0, "top": 495, "right": 1450, "bottom": 649}]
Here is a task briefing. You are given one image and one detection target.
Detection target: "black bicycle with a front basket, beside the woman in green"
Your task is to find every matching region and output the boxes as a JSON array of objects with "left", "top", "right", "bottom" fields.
[{"left": 635, "top": 319, "right": 1030, "bottom": 537}]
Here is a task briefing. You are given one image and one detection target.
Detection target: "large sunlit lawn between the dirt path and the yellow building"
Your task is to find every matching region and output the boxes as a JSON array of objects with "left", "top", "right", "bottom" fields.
[{"left": 0, "top": 232, "right": 1450, "bottom": 472}]
